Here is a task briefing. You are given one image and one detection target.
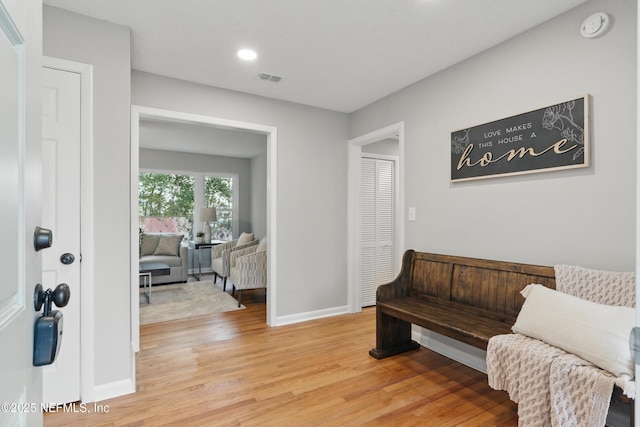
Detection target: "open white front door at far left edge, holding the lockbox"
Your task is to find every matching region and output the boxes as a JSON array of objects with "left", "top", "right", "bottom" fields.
[{"left": 0, "top": 0, "right": 42, "bottom": 426}]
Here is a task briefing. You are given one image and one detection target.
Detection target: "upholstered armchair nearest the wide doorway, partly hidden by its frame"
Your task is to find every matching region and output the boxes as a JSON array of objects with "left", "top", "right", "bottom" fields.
[{"left": 229, "top": 239, "right": 267, "bottom": 307}]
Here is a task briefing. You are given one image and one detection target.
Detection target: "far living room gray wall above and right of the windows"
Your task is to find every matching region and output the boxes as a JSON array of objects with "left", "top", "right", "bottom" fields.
[{"left": 139, "top": 147, "right": 255, "bottom": 237}]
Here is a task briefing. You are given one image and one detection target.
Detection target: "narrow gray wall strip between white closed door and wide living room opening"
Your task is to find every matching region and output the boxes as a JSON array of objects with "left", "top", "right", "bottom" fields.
[{"left": 43, "top": 6, "right": 132, "bottom": 387}]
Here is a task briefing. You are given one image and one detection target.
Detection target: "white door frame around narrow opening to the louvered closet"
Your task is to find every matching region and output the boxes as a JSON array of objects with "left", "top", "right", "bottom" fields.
[{"left": 347, "top": 122, "right": 404, "bottom": 313}]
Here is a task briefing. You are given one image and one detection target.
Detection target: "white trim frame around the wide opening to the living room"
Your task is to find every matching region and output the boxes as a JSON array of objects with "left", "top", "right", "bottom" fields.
[{"left": 130, "top": 105, "right": 277, "bottom": 356}]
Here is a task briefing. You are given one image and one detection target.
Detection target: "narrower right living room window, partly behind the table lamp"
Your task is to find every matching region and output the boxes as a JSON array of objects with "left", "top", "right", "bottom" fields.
[{"left": 204, "top": 176, "right": 233, "bottom": 241}]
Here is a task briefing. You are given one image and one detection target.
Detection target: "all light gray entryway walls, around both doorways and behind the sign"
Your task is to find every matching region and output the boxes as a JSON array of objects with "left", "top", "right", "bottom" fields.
[{"left": 44, "top": 0, "right": 636, "bottom": 402}]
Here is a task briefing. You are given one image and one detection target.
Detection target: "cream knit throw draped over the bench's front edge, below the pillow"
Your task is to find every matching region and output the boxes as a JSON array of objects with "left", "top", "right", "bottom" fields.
[{"left": 487, "top": 334, "right": 614, "bottom": 427}]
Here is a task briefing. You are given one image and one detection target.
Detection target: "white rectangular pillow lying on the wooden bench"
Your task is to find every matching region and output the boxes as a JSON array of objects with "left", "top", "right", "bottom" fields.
[{"left": 512, "top": 284, "right": 635, "bottom": 378}]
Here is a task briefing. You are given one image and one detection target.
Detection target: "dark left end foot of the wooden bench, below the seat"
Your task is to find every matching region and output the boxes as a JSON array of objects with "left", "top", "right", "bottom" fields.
[{"left": 369, "top": 308, "right": 420, "bottom": 359}]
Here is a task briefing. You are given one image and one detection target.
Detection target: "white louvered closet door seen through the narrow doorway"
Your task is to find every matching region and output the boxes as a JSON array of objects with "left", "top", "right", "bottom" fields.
[{"left": 360, "top": 158, "right": 394, "bottom": 307}]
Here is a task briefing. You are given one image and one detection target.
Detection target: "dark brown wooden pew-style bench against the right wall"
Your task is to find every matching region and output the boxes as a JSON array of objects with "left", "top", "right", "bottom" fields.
[{"left": 369, "top": 250, "right": 555, "bottom": 359}]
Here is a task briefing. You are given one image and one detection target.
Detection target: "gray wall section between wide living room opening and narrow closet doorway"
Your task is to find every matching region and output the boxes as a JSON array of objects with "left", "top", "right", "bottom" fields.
[{"left": 131, "top": 71, "right": 348, "bottom": 317}]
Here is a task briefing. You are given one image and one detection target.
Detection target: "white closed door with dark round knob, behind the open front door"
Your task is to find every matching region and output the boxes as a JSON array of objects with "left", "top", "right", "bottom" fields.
[{"left": 42, "top": 67, "right": 81, "bottom": 403}]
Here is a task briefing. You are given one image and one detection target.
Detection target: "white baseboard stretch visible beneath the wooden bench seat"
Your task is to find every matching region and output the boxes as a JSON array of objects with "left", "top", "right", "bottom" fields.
[{"left": 411, "top": 326, "right": 487, "bottom": 374}]
